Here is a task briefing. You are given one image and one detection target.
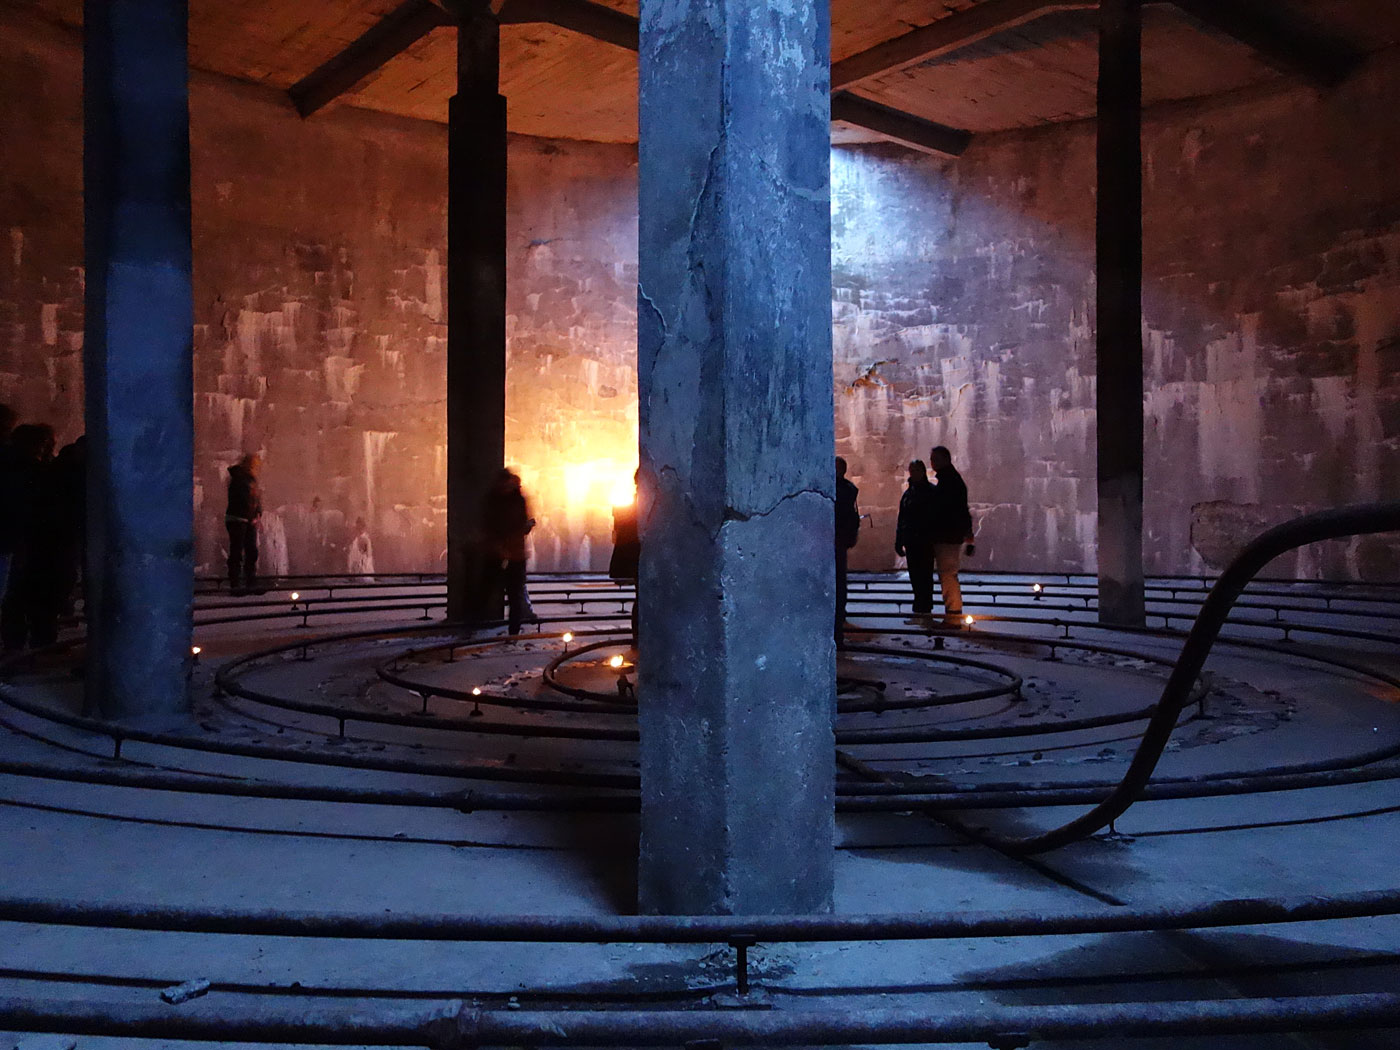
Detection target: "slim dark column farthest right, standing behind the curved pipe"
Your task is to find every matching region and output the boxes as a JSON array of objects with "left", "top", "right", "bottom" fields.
[{"left": 1096, "top": 0, "right": 1147, "bottom": 626}]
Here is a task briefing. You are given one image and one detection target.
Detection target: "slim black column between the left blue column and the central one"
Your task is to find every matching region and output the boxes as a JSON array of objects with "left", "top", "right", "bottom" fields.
[{"left": 447, "top": 0, "right": 505, "bottom": 620}]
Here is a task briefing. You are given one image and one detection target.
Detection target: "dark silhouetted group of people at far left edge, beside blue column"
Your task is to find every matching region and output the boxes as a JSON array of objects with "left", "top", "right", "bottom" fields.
[{"left": 0, "top": 405, "right": 87, "bottom": 652}]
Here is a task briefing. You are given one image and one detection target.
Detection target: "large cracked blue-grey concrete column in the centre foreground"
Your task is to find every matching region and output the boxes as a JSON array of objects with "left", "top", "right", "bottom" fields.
[{"left": 638, "top": 0, "right": 834, "bottom": 914}]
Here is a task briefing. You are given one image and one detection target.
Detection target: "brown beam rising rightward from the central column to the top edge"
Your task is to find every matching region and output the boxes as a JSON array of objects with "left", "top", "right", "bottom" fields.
[{"left": 832, "top": 0, "right": 1092, "bottom": 91}]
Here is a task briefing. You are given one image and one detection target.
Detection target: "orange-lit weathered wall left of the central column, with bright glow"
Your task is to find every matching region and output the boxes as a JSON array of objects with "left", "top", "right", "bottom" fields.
[{"left": 0, "top": 14, "right": 637, "bottom": 573}]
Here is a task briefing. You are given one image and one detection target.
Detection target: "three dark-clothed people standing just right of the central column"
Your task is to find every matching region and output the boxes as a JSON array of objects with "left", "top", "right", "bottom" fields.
[{"left": 836, "top": 445, "right": 976, "bottom": 648}]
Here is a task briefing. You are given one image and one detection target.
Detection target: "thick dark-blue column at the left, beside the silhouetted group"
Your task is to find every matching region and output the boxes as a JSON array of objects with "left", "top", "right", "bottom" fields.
[{"left": 83, "top": 0, "right": 195, "bottom": 717}]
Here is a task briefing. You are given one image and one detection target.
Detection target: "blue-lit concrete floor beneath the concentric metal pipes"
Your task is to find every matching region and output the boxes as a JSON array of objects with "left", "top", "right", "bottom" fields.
[{"left": 0, "top": 579, "right": 1400, "bottom": 1050}]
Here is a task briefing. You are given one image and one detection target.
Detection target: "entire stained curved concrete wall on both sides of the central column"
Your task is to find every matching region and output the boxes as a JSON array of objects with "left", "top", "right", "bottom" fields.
[{"left": 0, "top": 6, "right": 1400, "bottom": 578}]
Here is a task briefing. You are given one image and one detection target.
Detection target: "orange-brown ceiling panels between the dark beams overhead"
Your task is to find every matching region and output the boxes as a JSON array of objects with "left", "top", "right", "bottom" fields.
[{"left": 13, "top": 0, "right": 1400, "bottom": 149}]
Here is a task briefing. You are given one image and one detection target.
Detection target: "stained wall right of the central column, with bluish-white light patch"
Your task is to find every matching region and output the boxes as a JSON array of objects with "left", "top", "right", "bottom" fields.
[{"left": 833, "top": 56, "right": 1400, "bottom": 578}]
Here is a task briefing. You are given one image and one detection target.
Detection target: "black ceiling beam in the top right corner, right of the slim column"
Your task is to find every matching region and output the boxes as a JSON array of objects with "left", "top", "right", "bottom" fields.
[{"left": 1175, "top": 0, "right": 1365, "bottom": 87}]
